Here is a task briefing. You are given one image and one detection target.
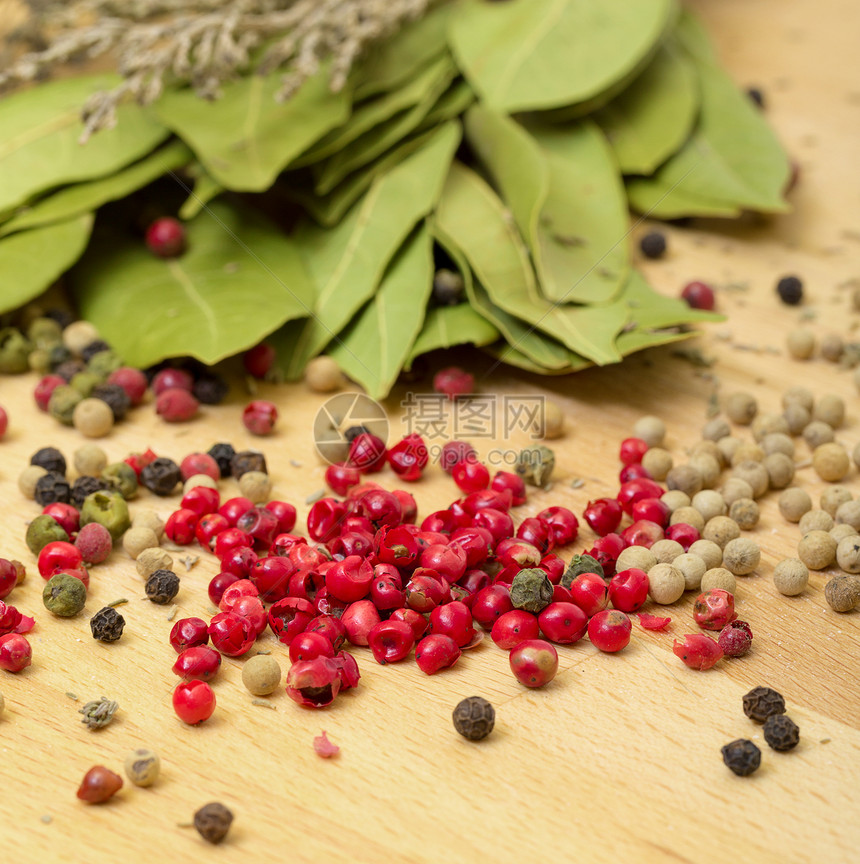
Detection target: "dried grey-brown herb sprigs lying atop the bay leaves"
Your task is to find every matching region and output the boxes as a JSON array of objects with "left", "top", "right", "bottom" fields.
[{"left": 0, "top": 0, "right": 434, "bottom": 139}]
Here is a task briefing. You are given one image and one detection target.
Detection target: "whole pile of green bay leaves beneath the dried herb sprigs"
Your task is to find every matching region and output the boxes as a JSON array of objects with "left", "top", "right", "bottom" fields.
[{"left": 0, "top": 0, "right": 789, "bottom": 397}]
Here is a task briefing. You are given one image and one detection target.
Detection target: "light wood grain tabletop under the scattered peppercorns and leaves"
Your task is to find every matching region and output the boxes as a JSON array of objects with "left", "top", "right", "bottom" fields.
[{"left": 0, "top": 0, "right": 860, "bottom": 864}]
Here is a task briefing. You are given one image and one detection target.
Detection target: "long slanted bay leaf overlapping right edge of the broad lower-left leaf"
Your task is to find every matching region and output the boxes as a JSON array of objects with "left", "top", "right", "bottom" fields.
[{"left": 275, "top": 121, "right": 461, "bottom": 379}]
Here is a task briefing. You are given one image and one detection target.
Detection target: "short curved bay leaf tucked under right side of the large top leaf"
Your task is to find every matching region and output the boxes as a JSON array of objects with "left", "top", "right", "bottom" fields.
[{"left": 593, "top": 41, "right": 699, "bottom": 174}]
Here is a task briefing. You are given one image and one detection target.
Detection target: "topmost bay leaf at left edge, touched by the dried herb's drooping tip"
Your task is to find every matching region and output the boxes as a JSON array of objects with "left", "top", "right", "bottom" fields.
[{"left": 0, "top": 75, "right": 169, "bottom": 212}]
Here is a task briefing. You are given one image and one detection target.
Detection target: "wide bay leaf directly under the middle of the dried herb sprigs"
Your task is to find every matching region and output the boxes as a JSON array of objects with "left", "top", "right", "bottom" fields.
[{"left": 155, "top": 67, "right": 351, "bottom": 192}]
